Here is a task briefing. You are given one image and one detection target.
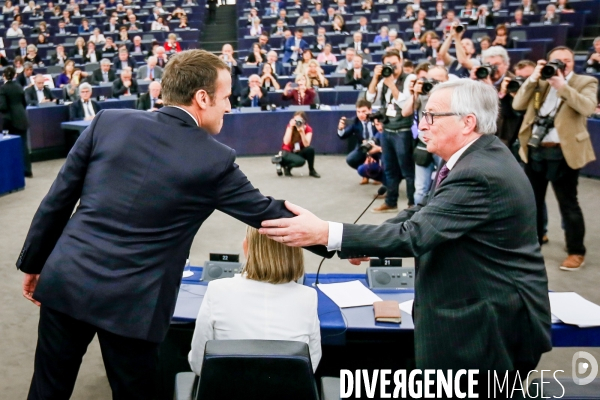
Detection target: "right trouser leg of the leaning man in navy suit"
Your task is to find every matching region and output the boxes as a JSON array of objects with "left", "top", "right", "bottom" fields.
[{"left": 98, "top": 329, "right": 159, "bottom": 400}]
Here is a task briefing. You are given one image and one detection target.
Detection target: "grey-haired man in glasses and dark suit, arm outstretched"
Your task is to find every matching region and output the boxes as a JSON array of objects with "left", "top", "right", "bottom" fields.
[{"left": 260, "top": 79, "right": 552, "bottom": 394}]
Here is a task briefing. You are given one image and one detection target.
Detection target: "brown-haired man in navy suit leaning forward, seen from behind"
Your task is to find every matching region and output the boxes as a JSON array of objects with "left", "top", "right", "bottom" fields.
[{"left": 17, "top": 50, "right": 326, "bottom": 400}]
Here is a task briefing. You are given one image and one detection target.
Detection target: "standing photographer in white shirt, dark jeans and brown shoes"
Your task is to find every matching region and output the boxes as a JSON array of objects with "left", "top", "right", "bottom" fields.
[{"left": 366, "top": 50, "right": 415, "bottom": 213}]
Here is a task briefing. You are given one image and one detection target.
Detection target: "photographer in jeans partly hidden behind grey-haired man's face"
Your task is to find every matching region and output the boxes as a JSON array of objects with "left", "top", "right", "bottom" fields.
[{"left": 402, "top": 65, "right": 448, "bottom": 205}]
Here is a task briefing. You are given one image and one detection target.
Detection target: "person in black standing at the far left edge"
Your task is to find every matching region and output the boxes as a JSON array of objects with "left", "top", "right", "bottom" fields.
[{"left": 0, "top": 67, "right": 32, "bottom": 177}]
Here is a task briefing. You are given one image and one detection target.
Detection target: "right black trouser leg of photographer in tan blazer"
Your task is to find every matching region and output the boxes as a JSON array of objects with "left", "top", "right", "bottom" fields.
[{"left": 552, "top": 160, "right": 586, "bottom": 255}]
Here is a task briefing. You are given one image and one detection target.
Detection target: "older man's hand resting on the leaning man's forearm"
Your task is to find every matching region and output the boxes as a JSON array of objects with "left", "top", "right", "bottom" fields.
[{"left": 258, "top": 201, "right": 329, "bottom": 247}]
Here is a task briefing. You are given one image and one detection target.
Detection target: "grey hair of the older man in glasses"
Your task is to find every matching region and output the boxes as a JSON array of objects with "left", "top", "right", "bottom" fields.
[{"left": 429, "top": 79, "right": 499, "bottom": 135}]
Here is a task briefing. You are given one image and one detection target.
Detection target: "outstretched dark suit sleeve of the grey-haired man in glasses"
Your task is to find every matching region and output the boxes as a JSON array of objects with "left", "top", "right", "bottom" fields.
[{"left": 340, "top": 170, "right": 493, "bottom": 258}]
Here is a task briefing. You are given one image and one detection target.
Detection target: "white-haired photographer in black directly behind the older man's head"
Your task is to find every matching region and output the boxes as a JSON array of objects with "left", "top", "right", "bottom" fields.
[{"left": 474, "top": 46, "right": 523, "bottom": 148}]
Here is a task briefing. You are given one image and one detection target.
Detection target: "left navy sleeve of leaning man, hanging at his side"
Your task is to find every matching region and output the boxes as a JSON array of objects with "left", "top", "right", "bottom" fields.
[{"left": 17, "top": 113, "right": 101, "bottom": 274}]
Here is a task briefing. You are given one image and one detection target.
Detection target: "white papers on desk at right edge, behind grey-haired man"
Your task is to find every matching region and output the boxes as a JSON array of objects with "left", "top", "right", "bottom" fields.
[{"left": 548, "top": 292, "right": 600, "bottom": 328}]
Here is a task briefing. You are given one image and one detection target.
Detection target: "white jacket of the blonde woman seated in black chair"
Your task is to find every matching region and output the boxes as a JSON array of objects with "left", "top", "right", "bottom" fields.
[{"left": 188, "top": 276, "right": 321, "bottom": 375}]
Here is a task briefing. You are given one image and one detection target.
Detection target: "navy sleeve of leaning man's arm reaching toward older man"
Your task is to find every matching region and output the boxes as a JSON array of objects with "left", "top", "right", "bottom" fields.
[{"left": 215, "top": 150, "right": 334, "bottom": 257}]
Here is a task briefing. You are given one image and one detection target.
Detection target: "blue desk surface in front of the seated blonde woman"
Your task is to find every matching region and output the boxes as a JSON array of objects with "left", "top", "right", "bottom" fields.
[{"left": 173, "top": 267, "right": 600, "bottom": 347}]
